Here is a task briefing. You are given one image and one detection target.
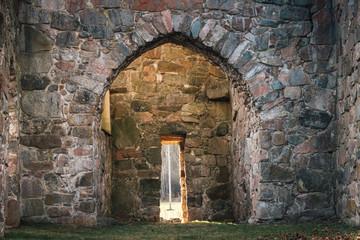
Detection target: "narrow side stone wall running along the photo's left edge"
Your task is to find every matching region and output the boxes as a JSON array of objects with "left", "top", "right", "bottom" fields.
[{"left": 0, "top": 1, "right": 19, "bottom": 236}]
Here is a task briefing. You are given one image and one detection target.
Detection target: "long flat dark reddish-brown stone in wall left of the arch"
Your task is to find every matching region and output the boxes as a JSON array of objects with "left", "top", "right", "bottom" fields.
[{"left": 20, "top": 135, "right": 62, "bottom": 149}]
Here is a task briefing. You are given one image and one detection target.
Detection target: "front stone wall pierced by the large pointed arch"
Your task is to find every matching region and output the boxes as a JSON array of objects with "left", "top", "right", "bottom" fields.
[{"left": 1, "top": 0, "right": 338, "bottom": 225}]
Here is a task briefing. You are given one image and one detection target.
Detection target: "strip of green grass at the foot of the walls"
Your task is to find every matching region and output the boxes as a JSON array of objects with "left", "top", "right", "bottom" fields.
[{"left": 5, "top": 222, "right": 360, "bottom": 240}]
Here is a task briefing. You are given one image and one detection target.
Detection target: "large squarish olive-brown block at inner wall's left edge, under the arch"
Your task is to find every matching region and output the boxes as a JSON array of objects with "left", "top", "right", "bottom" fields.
[{"left": 111, "top": 117, "right": 140, "bottom": 149}]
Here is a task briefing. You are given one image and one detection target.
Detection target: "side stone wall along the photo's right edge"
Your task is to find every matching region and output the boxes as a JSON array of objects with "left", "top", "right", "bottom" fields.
[{"left": 333, "top": 1, "right": 360, "bottom": 225}]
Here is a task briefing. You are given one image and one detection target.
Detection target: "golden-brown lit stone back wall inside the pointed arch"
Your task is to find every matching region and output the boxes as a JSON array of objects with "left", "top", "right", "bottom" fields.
[{"left": 110, "top": 43, "right": 234, "bottom": 221}]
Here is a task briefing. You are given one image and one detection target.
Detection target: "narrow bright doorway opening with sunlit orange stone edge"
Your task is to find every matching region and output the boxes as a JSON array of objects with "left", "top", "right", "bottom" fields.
[{"left": 160, "top": 137, "right": 188, "bottom": 222}]
